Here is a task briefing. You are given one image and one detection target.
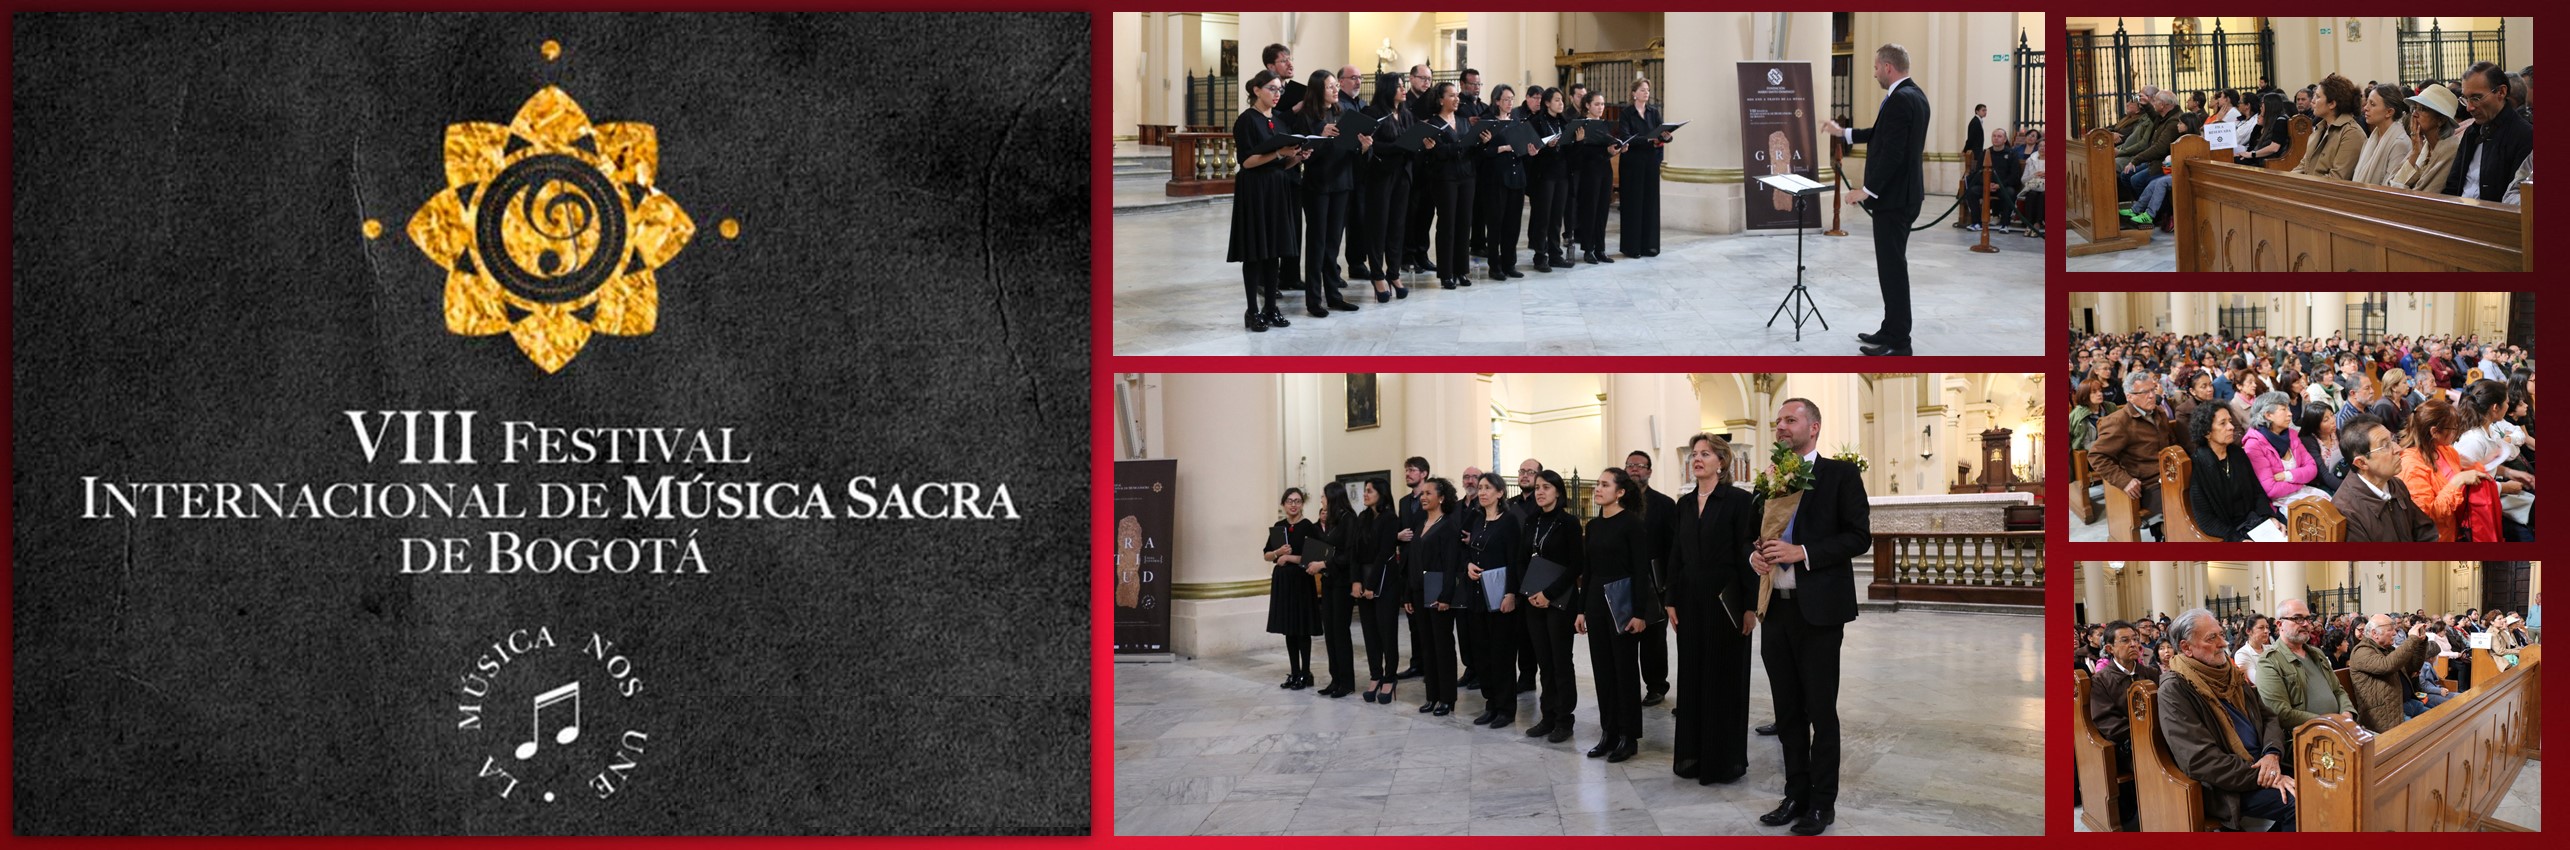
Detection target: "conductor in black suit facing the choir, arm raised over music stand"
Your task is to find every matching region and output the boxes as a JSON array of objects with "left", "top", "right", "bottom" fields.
[{"left": 1820, "top": 44, "right": 1928, "bottom": 357}]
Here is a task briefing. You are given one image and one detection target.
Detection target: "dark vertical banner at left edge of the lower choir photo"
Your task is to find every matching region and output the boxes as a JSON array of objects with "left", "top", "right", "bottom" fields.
[{"left": 1108, "top": 460, "right": 1177, "bottom": 655}]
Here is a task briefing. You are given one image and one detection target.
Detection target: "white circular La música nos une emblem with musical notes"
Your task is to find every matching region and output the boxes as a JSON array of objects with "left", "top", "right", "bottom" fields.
[{"left": 452, "top": 627, "right": 653, "bottom": 806}]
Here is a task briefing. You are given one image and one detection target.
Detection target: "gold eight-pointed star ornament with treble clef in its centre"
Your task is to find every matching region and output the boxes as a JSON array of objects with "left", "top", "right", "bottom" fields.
[{"left": 409, "top": 85, "right": 696, "bottom": 372}]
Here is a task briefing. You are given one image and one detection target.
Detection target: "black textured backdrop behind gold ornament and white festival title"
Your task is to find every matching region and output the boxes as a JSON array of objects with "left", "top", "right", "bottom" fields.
[{"left": 10, "top": 15, "right": 1090, "bottom": 835}]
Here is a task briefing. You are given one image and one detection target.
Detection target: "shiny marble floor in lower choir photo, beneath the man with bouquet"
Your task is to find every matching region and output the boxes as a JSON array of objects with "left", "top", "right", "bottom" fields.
[{"left": 1113, "top": 611, "right": 2043, "bottom": 835}]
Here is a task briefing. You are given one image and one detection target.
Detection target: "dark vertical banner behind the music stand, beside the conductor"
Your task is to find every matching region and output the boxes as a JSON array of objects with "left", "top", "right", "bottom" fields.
[{"left": 1740, "top": 62, "right": 1822, "bottom": 231}]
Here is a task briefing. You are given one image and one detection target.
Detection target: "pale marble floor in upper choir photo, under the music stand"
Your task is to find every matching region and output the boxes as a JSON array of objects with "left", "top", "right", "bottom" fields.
[{"left": 1113, "top": 185, "right": 2048, "bottom": 357}]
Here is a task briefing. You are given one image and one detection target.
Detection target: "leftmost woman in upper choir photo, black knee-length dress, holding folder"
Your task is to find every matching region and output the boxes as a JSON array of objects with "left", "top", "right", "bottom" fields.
[{"left": 1223, "top": 72, "right": 1311, "bottom": 334}]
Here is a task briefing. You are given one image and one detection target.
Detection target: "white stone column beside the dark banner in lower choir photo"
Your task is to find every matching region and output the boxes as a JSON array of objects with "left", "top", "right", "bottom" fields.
[{"left": 1159, "top": 372, "right": 1285, "bottom": 657}]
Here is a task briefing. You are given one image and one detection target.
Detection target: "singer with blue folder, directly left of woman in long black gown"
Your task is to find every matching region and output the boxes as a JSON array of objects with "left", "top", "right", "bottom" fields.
[{"left": 1570, "top": 467, "right": 1660, "bottom": 763}]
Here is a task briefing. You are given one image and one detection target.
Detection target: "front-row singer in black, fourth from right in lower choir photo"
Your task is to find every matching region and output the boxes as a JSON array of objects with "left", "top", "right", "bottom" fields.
[{"left": 1519, "top": 470, "right": 1588, "bottom": 745}]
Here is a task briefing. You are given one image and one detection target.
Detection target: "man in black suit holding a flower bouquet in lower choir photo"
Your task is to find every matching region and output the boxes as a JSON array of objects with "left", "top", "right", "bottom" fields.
[{"left": 1750, "top": 400, "right": 1870, "bottom": 835}]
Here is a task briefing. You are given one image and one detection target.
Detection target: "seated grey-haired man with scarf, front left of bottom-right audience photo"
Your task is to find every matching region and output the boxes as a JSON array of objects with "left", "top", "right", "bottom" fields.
[{"left": 2159, "top": 609, "right": 2298, "bottom": 832}]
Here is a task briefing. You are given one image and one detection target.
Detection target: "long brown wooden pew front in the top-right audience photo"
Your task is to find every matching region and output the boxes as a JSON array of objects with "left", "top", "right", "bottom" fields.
[{"left": 2169, "top": 136, "right": 2534, "bottom": 272}]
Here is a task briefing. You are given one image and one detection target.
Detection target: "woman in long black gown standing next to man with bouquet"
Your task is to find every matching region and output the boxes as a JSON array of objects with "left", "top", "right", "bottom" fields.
[{"left": 1663, "top": 434, "right": 1758, "bottom": 786}]
